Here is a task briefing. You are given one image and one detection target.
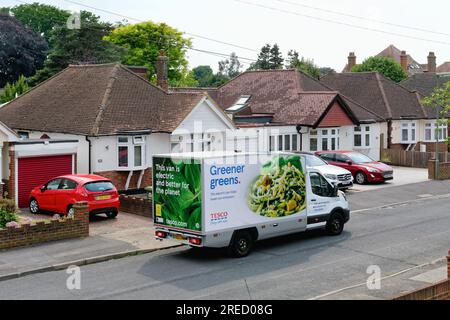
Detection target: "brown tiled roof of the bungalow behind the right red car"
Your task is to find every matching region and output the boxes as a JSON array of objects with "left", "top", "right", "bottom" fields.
[{"left": 321, "top": 72, "right": 428, "bottom": 119}]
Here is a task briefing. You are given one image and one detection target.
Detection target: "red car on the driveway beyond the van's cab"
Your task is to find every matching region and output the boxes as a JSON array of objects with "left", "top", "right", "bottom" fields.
[{"left": 316, "top": 151, "right": 394, "bottom": 184}]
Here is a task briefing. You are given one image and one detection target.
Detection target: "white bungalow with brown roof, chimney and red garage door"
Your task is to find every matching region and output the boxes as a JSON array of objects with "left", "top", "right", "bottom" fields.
[{"left": 0, "top": 57, "right": 235, "bottom": 207}]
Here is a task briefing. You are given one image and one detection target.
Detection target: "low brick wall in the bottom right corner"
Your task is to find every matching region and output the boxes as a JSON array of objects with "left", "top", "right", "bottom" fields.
[{"left": 393, "top": 251, "right": 450, "bottom": 300}]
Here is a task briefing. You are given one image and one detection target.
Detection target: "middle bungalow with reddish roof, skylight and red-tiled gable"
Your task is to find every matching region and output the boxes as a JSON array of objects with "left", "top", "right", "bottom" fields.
[{"left": 172, "top": 70, "right": 384, "bottom": 159}]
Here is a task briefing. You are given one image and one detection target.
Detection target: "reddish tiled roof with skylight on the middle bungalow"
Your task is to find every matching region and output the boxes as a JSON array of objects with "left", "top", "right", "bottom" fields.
[{"left": 173, "top": 70, "right": 381, "bottom": 125}]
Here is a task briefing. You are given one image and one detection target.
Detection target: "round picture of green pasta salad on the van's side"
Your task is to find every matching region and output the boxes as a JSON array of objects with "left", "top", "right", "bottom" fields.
[{"left": 248, "top": 156, "right": 306, "bottom": 218}]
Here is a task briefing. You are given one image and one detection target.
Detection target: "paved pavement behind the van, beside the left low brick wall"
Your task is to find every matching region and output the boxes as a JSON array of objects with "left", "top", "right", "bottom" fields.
[{"left": 0, "top": 211, "right": 178, "bottom": 279}]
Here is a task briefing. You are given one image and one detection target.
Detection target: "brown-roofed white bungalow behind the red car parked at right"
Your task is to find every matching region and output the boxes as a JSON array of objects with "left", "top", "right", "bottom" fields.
[{"left": 321, "top": 72, "right": 447, "bottom": 152}]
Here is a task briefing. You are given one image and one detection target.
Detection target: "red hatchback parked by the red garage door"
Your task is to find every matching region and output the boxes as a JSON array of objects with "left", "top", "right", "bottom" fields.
[{"left": 29, "top": 174, "right": 120, "bottom": 218}]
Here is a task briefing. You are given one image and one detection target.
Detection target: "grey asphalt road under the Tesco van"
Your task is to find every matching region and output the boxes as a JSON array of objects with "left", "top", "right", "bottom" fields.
[{"left": 0, "top": 182, "right": 450, "bottom": 299}]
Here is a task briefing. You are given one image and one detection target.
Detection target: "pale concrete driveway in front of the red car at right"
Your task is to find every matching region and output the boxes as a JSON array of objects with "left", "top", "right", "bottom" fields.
[{"left": 348, "top": 166, "right": 429, "bottom": 193}]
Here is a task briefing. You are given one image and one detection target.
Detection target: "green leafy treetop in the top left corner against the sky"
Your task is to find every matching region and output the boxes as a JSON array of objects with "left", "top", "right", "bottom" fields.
[{"left": 11, "top": 2, "right": 70, "bottom": 42}]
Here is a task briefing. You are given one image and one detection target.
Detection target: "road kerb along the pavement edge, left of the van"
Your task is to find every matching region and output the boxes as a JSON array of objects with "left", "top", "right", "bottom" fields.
[{"left": 0, "top": 244, "right": 183, "bottom": 282}]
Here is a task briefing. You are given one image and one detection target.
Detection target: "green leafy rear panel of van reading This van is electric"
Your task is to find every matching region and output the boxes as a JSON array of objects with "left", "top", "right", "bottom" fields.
[{"left": 153, "top": 158, "right": 202, "bottom": 231}]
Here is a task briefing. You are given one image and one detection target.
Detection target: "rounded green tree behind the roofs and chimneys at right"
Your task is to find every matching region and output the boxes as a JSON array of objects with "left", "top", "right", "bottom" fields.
[{"left": 351, "top": 56, "right": 408, "bottom": 82}]
